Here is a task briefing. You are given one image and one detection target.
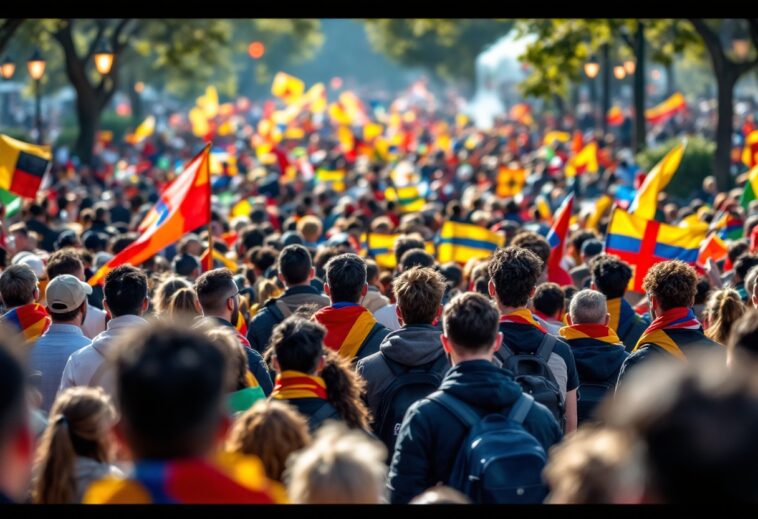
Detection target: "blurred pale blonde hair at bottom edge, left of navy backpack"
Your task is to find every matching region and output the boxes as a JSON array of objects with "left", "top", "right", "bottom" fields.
[{"left": 284, "top": 422, "right": 387, "bottom": 504}]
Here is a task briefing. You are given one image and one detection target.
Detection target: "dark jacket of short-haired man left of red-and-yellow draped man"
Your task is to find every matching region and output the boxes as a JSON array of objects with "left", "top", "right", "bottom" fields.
[{"left": 247, "top": 286, "right": 329, "bottom": 353}]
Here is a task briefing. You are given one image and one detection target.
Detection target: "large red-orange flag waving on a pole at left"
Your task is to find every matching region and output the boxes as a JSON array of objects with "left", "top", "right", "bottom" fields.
[{"left": 89, "top": 144, "right": 211, "bottom": 286}]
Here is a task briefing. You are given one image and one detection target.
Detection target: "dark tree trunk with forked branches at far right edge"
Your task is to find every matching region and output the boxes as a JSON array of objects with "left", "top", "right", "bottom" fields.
[{"left": 689, "top": 18, "right": 758, "bottom": 191}]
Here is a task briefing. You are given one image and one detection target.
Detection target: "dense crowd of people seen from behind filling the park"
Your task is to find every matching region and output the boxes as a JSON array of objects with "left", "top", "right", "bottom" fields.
[{"left": 0, "top": 77, "right": 758, "bottom": 504}]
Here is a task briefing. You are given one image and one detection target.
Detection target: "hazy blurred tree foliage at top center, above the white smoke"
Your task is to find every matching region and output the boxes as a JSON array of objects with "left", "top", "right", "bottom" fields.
[{"left": 364, "top": 18, "right": 513, "bottom": 90}]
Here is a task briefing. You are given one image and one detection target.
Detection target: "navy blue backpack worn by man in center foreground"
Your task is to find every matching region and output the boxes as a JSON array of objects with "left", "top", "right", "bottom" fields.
[{"left": 428, "top": 391, "right": 548, "bottom": 504}]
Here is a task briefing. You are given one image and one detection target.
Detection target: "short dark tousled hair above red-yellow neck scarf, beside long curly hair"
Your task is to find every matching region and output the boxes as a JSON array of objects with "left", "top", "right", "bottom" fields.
[{"left": 270, "top": 315, "right": 326, "bottom": 373}]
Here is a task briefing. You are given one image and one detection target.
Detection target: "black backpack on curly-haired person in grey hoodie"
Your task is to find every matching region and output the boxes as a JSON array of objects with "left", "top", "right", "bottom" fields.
[{"left": 374, "top": 354, "right": 447, "bottom": 456}]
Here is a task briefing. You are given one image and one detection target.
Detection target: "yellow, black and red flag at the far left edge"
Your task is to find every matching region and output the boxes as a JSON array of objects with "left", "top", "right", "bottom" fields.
[{"left": 0, "top": 134, "right": 53, "bottom": 198}]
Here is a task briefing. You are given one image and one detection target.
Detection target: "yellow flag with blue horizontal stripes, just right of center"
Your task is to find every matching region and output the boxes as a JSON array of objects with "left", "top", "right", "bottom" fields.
[{"left": 437, "top": 221, "right": 505, "bottom": 263}]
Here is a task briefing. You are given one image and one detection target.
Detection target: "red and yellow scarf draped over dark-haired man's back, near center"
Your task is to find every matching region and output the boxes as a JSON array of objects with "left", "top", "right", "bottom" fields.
[{"left": 313, "top": 303, "right": 376, "bottom": 360}]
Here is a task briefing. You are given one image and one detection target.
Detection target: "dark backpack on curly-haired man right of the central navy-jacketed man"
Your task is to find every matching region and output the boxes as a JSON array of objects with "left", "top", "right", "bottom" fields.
[{"left": 500, "top": 333, "right": 566, "bottom": 429}]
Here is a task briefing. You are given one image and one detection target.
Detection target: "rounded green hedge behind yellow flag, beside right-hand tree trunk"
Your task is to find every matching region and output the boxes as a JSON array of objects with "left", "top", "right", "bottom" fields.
[{"left": 637, "top": 136, "right": 716, "bottom": 199}]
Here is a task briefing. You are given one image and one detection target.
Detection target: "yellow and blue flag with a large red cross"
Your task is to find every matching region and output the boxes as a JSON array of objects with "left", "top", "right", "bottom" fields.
[{"left": 605, "top": 208, "right": 705, "bottom": 293}]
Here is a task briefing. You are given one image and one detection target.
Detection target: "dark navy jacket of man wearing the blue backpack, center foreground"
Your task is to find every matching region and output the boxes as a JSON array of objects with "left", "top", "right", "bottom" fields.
[{"left": 387, "top": 360, "right": 562, "bottom": 504}]
